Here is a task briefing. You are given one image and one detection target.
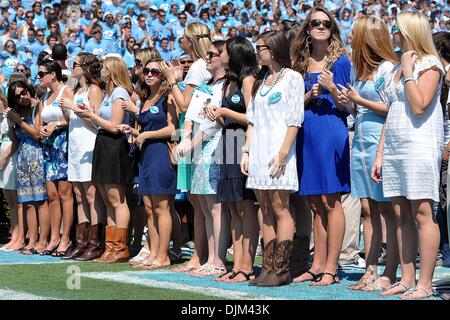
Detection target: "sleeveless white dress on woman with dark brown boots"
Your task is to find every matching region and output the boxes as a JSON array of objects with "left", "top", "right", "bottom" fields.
[{"left": 67, "top": 88, "right": 97, "bottom": 182}]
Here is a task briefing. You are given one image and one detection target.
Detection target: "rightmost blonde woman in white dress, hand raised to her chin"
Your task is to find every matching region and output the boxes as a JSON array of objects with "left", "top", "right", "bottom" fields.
[{"left": 372, "top": 12, "right": 444, "bottom": 299}]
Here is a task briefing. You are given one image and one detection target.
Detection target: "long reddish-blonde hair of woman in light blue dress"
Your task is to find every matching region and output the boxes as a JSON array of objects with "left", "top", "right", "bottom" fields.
[{"left": 352, "top": 16, "right": 397, "bottom": 81}]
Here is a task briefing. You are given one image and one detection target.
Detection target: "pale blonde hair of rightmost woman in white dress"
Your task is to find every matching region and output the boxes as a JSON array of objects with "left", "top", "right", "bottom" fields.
[{"left": 397, "top": 12, "right": 439, "bottom": 59}]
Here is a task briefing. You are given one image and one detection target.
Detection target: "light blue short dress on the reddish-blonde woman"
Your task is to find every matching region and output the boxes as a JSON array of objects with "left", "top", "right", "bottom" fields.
[{"left": 351, "top": 61, "right": 394, "bottom": 201}]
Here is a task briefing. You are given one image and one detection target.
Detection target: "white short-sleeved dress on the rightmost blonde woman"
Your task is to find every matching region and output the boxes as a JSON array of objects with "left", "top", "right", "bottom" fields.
[{"left": 382, "top": 55, "right": 445, "bottom": 202}]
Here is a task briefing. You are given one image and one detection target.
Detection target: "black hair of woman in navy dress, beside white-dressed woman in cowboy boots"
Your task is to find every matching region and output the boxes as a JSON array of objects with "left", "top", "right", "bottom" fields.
[{"left": 226, "top": 37, "right": 258, "bottom": 89}]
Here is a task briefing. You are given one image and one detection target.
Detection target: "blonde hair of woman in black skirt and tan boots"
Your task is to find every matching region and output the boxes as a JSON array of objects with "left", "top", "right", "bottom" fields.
[{"left": 103, "top": 57, "right": 133, "bottom": 95}]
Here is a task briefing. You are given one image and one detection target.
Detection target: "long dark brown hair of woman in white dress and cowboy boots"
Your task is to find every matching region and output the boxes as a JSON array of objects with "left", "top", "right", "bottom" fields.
[{"left": 252, "top": 30, "right": 291, "bottom": 97}]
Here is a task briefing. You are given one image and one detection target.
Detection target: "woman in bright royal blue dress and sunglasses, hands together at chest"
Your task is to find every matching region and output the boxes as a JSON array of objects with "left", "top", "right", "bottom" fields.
[{"left": 293, "top": 7, "right": 351, "bottom": 286}]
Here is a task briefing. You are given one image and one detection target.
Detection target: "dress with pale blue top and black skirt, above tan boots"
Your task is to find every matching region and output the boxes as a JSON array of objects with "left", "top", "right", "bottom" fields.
[{"left": 92, "top": 87, "right": 134, "bottom": 184}]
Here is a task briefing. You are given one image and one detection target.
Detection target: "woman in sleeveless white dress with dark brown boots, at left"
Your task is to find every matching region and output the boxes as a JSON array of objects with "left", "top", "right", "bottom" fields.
[{"left": 61, "top": 52, "right": 105, "bottom": 260}]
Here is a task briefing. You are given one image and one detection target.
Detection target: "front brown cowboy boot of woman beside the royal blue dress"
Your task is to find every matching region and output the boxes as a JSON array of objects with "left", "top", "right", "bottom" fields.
[{"left": 257, "top": 240, "right": 292, "bottom": 287}]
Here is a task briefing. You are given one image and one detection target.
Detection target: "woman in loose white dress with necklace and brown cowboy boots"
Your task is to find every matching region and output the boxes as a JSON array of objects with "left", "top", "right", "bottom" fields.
[{"left": 241, "top": 31, "right": 305, "bottom": 286}]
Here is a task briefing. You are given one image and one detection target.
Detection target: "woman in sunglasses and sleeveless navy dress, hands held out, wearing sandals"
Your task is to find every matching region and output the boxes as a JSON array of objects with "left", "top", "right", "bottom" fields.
[{"left": 120, "top": 58, "right": 178, "bottom": 269}]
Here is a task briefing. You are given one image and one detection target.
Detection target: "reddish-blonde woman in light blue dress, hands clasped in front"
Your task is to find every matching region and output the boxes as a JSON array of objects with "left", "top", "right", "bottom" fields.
[{"left": 340, "top": 17, "right": 398, "bottom": 290}]
